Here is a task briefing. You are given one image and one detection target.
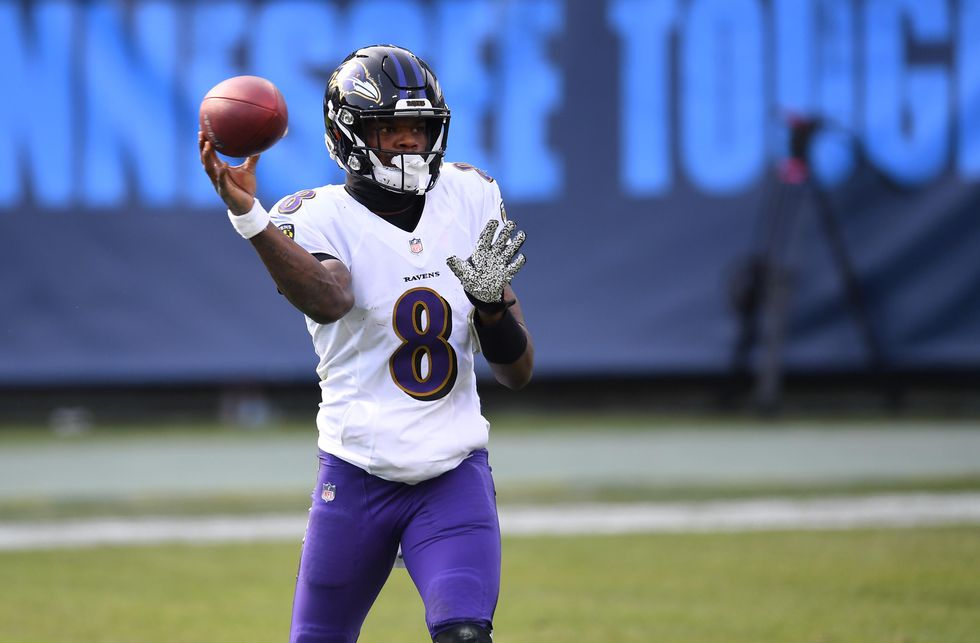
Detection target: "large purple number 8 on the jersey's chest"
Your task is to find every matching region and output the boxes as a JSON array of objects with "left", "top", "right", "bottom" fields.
[{"left": 388, "top": 288, "right": 457, "bottom": 401}]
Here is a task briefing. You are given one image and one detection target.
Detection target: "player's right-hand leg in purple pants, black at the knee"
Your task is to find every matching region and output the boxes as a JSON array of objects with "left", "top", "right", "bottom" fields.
[{"left": 402, "top": 450, "right": 500, "bottom": 643}]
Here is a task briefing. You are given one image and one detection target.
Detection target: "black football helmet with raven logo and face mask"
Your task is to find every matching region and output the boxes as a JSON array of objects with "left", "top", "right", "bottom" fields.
[{"left": 323, "top": 45, "right": 449, "bottom": 194}]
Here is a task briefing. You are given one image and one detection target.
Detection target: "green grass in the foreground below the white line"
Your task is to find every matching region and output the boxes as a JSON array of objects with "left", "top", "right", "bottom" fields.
[{"left": 0, "top": 527, "right": 980, "bottom": 643}]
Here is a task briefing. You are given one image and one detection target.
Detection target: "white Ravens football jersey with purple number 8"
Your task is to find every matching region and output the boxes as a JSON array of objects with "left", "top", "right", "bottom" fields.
[{"left": 272, "top": 163, "right": 504, "bottom": 484}]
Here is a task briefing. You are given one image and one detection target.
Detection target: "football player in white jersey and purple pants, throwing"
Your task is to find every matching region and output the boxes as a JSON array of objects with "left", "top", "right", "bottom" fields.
[{"left": 199, "top": 45, "right": 534, "bottom": 643}]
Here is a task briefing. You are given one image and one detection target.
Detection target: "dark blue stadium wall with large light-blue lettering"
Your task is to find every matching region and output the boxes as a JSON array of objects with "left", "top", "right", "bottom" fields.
[{"left": 0, "top": 0, "right": 980, "bottom": 386}]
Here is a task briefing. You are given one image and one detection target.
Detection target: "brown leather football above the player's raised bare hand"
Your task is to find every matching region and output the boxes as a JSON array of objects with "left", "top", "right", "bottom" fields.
[{"left": 200, "top": 76, "right": 289, "bottom": 157}]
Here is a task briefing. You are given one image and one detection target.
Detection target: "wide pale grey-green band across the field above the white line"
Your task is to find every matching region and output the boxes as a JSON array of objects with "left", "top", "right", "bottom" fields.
[{"left": 0, "top": 426, "right": 980, "bottom": 500}]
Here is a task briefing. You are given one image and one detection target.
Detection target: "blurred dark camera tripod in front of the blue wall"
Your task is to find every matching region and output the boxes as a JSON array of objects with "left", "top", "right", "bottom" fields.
[{"left": 731, "top": 119, "right": 885, "bottom": 415}]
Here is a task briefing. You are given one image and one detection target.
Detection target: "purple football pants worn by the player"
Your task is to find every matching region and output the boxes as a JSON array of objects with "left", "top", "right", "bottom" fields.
[{"left": 289, "top": 450, "right": 500, "bottom": 643}]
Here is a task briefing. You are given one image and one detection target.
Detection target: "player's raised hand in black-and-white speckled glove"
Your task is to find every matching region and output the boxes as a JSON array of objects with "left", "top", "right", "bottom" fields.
[{"left": 446, "top": 219, "right": 526, "bottom": 312}]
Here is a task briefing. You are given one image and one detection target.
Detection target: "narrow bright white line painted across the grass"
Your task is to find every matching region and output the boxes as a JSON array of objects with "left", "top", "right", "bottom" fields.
[{"left": 0, "top": 493, "right": 980, "bottom": 551}]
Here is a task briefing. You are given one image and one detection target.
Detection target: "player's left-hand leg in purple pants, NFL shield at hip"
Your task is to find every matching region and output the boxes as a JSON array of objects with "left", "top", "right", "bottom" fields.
[{"left": 289, "top": 454, "right": 398, "bottom": 643}]
